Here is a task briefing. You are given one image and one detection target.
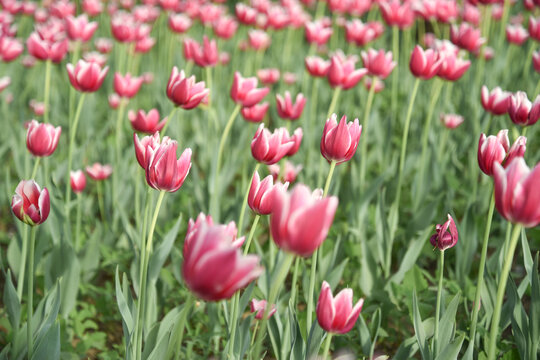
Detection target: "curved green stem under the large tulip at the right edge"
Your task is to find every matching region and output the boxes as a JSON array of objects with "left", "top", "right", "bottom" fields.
[{"left": 487, "top": 224, "right": 522, "bottom": 360}]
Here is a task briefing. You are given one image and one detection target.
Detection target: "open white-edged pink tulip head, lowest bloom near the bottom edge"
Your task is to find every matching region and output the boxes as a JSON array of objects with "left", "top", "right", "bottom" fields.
[{"left": 316, "top": 281, "right": 364, "bottom": 334}]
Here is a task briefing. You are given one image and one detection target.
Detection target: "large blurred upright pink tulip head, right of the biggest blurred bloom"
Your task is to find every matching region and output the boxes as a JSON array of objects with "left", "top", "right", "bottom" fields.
[{"left": 270, "top": 184, "right": 338, "bottom": 257}]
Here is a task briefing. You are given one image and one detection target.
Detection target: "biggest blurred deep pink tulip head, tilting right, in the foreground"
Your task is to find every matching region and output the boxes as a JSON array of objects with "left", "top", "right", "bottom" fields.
[{"left": 182, "top": 223, "right": 263, "bottom": 301}]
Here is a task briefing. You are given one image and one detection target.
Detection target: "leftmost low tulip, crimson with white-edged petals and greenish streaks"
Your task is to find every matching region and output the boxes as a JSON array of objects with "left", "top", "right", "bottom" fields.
[{"left": 11, "top": 180, "right": 51, "bottom": 226}]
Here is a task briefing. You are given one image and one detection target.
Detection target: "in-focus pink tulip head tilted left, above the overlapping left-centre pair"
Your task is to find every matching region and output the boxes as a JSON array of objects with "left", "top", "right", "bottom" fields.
[{"left": 167, "top": 66, "right": 210, "bottom": 110}]
